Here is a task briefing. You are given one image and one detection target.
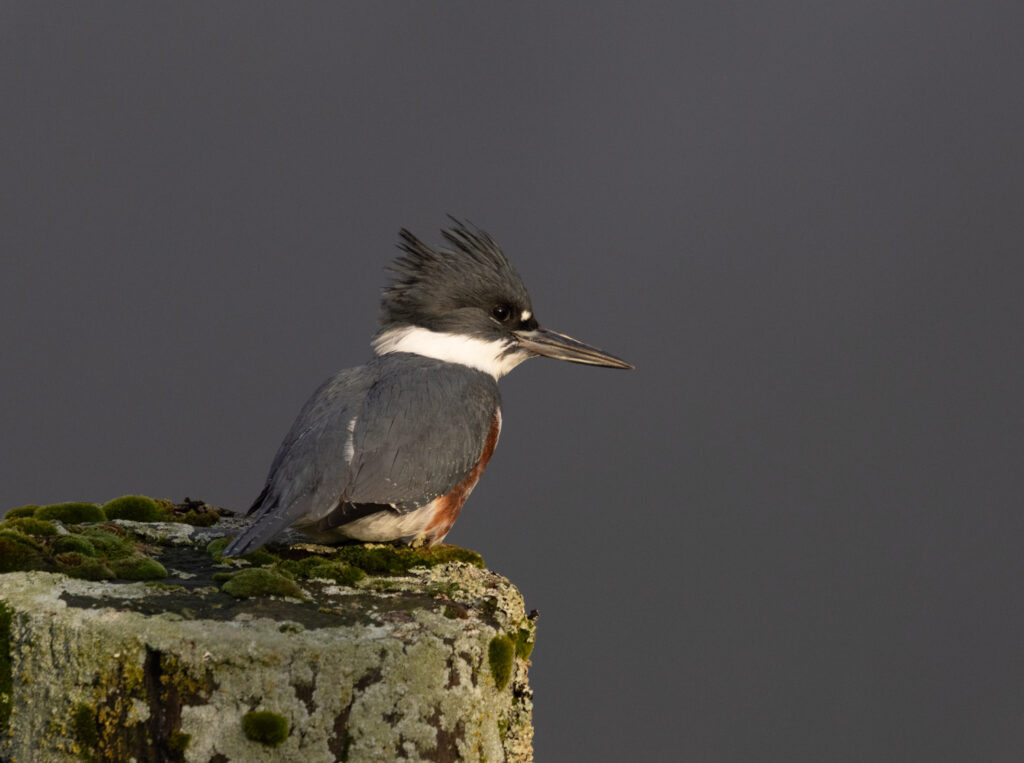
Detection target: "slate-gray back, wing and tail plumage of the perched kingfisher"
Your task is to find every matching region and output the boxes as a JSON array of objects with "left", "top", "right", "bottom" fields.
[{"left": 226, "top": 352, "right": 501, "bottom": 555}]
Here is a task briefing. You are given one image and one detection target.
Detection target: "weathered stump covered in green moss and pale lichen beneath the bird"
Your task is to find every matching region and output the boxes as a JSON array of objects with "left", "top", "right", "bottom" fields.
[{"left": 0, "top": 497, "right": 536, "bottom": 763}]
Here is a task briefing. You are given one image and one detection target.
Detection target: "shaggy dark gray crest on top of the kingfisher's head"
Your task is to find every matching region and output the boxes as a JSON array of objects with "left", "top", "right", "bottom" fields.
[{"left": 380, "top": 217, "right": 530, "bottom": 330}]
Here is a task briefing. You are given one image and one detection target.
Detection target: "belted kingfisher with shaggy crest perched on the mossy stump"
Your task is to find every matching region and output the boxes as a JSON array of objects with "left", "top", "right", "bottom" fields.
[{"left": 225, "top": 218, "right": 633, "bottom": 556}]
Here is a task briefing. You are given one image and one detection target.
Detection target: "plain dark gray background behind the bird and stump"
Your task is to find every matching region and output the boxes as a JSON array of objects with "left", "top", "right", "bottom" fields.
[{"left": 0, "top": 0, "right": 1024, "bottom": 761}]
